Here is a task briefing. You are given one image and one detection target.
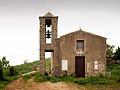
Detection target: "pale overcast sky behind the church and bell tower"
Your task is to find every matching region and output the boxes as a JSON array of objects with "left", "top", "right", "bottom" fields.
[{"left": 0, "top": 0, "right": 120, "bottom": 65}]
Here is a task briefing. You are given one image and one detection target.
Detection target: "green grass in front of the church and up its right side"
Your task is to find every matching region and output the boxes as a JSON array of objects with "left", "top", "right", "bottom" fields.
[{"left": 34, "top": 64, "right": 120, "bottom": 90}]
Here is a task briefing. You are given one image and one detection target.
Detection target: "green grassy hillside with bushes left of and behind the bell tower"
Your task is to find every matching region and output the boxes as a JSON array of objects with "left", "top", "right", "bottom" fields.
[{"left": 0, "top": 57, "right": 50, "bottom": 88}]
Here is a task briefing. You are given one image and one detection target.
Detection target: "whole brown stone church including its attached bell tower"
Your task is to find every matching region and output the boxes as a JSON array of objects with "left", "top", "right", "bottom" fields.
[{"left": 39, "top": 12, "right": 106, "bottom": 77}]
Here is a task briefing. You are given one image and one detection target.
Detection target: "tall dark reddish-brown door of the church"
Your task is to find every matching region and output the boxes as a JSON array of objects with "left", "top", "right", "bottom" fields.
[{"left": 75, "top": 57, "right": 85, "bottom": 77}]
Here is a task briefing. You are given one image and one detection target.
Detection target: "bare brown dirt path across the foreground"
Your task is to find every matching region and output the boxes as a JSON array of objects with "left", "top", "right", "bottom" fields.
[{"left": 5, "top": 77, "right": 85, "bottom": 90}]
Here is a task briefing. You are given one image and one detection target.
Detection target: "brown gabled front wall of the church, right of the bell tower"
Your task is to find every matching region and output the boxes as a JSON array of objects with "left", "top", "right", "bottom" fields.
[{"left": 60, "top": 30, "right": 106, "bottom": 77}]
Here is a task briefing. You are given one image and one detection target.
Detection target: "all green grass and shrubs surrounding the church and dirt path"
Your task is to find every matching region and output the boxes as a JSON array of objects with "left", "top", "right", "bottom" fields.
[{"left": 0, "top": 53, "right": 120, "bottom": 89}]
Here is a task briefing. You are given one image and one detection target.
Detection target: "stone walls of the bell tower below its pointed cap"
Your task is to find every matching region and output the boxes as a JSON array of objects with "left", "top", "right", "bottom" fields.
[{"left": 39, "top": 16, "right": 58, "bottom": 75}]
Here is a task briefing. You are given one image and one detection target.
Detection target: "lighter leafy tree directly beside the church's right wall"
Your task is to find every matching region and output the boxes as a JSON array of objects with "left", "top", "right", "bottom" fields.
[{"left": 106, "top": 44, "right": 115, "bottom": 60}]
